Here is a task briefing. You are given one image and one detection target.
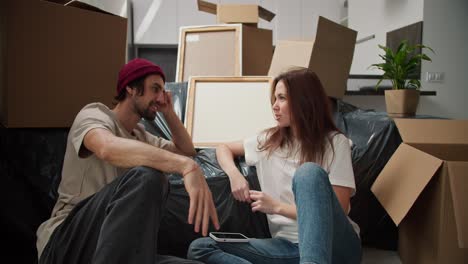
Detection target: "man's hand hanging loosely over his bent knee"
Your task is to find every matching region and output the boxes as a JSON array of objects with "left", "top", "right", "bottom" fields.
[{"left": 184, "top": 165, "right": 219, "bottom": 236}]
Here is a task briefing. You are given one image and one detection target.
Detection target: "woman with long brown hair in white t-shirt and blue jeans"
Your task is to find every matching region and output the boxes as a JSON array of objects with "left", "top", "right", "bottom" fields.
[{"left": 188, "top": 69, "right": 361, "bottom": 264}]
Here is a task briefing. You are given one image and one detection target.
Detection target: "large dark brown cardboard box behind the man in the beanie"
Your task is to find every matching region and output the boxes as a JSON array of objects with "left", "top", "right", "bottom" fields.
[{"left": 0, "top": 0, "right": 127, "bottom": 128}]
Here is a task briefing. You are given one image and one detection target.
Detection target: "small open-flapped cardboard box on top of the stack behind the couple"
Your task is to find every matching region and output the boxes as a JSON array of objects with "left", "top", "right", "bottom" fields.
[{"left": 197, "top": 0, "right": 275, "bottom": 26}]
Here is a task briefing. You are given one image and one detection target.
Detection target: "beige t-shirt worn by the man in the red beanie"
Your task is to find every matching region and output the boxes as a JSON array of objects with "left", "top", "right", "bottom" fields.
[{"left": 36, "top": 103, "right": 176, "bottom": 256}]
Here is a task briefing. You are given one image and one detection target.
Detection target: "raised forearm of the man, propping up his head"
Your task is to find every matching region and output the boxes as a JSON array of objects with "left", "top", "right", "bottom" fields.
[{"left": 164, "top": 111, "right": 196, "bottom": 156}]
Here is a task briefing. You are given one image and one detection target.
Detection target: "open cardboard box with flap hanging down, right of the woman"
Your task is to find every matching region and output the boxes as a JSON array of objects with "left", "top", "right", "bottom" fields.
[{"left": 371, "top": 119, "right": 468, "bottom": 264}]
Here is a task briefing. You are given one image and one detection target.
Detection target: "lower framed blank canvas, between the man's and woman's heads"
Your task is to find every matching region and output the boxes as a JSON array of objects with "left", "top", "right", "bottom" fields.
[{"left": 185, "top": 77, "right": 276, "bottom": 148}]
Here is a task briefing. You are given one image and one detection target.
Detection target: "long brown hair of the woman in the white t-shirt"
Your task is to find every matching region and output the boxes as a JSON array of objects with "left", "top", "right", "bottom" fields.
[{"left": 258, "top": 68, "right": 339, "bottom": 165}]
